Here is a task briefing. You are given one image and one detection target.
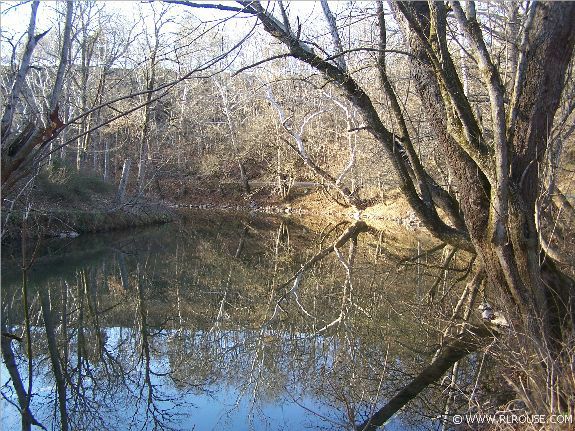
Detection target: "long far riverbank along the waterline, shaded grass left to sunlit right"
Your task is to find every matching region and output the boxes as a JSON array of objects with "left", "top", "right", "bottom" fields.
[{"left": 2, "top": 164, "right": 419, "bottom": 242}]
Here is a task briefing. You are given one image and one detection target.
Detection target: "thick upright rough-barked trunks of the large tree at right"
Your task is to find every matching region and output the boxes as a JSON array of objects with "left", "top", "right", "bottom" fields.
[{"left": 398, "top": 2, "right": 575, "bottom": 413}]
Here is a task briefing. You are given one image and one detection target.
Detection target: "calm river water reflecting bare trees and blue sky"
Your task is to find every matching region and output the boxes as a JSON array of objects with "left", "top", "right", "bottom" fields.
[{"left": 0, "top": 214, "right": 460, "bottom": 430}]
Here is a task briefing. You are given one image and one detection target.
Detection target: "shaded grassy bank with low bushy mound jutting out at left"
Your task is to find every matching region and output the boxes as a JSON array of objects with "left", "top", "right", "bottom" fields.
[{"left": 2, "top": 165, "right": 177, "bottom": 242}]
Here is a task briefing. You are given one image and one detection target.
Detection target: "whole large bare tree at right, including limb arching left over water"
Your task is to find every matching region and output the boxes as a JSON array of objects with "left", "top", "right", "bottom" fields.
[{"left": 170, "top": 0, "right": 575, "bottom": 425}]
